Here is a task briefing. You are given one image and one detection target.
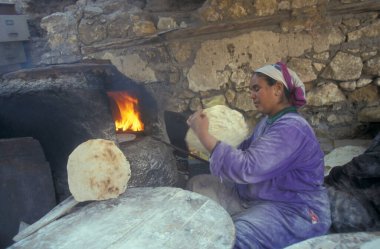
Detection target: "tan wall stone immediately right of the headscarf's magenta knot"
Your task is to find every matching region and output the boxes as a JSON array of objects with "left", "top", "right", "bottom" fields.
[{"left": 307, "top": 82, "right": 346, "bottom": 106}]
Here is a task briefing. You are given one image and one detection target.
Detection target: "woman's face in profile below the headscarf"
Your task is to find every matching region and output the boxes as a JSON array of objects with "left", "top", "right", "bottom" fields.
[{"left": 250, "top": 74, "right": 279, "bottom": 115}]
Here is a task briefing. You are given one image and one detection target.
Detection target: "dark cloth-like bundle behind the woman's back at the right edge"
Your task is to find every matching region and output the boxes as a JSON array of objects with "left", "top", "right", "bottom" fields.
[{"left": 325, "top": 133, "right": 380, "bottom": 232}]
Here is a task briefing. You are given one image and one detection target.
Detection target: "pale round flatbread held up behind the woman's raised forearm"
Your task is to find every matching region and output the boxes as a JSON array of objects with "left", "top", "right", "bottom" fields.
[{"left": 185, "top": 105, "right": 249, "bottom": 159}]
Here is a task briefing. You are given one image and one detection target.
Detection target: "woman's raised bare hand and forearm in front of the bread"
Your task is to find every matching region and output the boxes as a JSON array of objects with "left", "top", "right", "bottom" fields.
[{"left": 186, "top": 110, "right": 218, "bottom": 152}]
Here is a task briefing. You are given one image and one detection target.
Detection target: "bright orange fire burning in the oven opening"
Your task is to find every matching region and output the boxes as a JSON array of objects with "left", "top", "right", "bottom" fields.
[{"left": 107, "top": 92, "right": 144, "bottom": 131}]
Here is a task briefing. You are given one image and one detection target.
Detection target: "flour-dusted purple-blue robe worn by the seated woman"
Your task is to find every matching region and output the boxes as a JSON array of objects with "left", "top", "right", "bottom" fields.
[{"left": 210, "top": 113, "right": 331, "bottom": 248}]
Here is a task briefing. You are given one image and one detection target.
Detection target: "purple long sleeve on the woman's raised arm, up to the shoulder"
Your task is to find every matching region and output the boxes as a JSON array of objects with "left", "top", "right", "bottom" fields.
[{"left": 210, "top": 114, "right": 319, "bottom": 184}]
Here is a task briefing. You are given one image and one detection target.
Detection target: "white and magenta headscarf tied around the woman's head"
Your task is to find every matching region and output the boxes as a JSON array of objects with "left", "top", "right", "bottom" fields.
[{"left": 255, "top": 62, "right": 306, "bottom": 107}]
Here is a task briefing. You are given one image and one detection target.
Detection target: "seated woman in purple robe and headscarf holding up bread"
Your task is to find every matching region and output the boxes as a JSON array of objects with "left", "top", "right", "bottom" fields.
[{"left": 187, "top": 63, "right": 331, "bottom": 249}]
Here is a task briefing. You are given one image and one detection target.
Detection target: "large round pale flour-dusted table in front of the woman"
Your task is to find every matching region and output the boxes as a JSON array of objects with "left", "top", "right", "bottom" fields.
[{"left": 10, "top": 187, "right": 235, "bottom": 249}]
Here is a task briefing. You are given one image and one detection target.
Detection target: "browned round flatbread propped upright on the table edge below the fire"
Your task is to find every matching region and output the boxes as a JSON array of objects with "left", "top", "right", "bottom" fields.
[{"left": 67, "top": 139, "right": 131, "bottom": 201}]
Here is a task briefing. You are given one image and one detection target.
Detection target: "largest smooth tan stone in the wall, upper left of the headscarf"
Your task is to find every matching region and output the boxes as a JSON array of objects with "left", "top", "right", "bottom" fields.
[{"left": 187, "top": 31, "right": 311, "bottom": 92}]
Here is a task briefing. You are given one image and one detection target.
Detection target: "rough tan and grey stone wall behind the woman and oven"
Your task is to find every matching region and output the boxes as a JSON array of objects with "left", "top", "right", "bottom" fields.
[{"left": 6, "top": 0, "right": 380, "bottom": 138}]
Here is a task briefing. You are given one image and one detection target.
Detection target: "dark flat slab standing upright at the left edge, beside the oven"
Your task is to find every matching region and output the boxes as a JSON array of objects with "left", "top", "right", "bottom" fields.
[{"left": 0, "top": 137, "right": 56, "bottom": 248}]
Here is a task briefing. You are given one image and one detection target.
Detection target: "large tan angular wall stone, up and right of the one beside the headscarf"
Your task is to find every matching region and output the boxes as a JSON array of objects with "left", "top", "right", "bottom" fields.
[{"left": 321, "top": 52, "right": 363, "bottom": 80}]
